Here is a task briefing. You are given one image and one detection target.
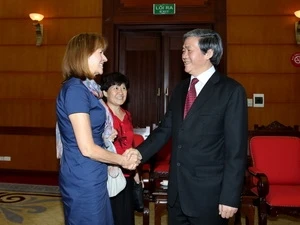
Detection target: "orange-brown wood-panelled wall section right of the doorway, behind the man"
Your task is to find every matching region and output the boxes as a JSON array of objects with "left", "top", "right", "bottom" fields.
[{"left": 227, "top": 0, "right": 300, "bottom": 129}]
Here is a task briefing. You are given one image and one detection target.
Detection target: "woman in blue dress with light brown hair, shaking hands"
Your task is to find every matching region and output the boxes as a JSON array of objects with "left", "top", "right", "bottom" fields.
[{"left": 56, "top": 33, "right": 140, "bottom": 225}]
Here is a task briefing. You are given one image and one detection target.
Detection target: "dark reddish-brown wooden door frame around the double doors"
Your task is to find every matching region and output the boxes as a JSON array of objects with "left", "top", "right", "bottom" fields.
[{"left": 102, "top": 0, "right": 227, "bottom": 74}]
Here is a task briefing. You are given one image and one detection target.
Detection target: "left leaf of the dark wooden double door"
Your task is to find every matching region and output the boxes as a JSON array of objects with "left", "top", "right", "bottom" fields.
[{"left": 118, "top": 31, "right": 162, "bottom": 127}]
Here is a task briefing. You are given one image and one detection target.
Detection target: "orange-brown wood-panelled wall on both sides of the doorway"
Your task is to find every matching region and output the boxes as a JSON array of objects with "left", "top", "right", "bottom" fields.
[{"left": 0, "top": 0, "right": 300, "bottom": 173}]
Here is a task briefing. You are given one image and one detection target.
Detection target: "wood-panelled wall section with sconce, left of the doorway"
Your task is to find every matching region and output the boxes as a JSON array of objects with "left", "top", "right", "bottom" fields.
[{"left": 0, "top": 0, "right": 102, "bottom": 172}]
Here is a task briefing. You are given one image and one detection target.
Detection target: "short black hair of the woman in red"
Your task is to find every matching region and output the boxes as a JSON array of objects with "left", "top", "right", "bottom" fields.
[{"left": 99, "top": 72, "right": 129, "bottom": 91}]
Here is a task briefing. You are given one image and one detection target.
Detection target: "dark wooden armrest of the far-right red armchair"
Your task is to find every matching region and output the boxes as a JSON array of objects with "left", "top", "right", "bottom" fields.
[{"left": 248, "top": 167, "right": 269, "bottom": 198}]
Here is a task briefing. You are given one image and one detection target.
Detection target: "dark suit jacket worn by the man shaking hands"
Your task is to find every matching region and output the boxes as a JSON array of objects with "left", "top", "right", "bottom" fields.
[{"left": 138, "top": 72, "right": 248, "bottom": 217}]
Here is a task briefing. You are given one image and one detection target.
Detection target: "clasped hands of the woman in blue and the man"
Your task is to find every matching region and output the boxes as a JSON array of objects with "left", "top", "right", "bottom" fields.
[{"left": 121, "top": 148, "right": 142, "bottom": 170}]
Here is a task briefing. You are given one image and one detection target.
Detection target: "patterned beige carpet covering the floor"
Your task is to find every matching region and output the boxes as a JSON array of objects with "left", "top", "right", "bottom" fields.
[{"left": 0, "top": 183, "right": 300, "bottom": 225}]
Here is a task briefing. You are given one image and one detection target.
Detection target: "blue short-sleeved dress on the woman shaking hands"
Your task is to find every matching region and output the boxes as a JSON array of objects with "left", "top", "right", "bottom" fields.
[{"left": 56, "top": 78, "right": 114, "bottom": 225}]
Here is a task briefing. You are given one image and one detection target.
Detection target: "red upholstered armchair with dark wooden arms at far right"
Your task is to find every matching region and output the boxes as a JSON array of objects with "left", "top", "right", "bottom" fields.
[{"left": 248, "top": 136, "right": 300, "bottom": 225}]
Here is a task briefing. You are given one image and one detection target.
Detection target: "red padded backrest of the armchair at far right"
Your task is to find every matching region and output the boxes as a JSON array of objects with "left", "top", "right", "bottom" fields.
[{"left": 250, "top": 136, "right": 300, "bottom": 185}]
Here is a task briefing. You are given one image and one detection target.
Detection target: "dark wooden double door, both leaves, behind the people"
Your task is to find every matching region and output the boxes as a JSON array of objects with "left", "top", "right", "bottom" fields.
[{"left": 116, "top": 27, "right": 206, "bottom": 127}]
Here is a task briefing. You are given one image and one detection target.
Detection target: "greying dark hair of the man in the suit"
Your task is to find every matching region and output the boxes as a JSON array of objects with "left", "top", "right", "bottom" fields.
[{"left": 183, "top": 29, "right": 223, "bottom": 66}]
